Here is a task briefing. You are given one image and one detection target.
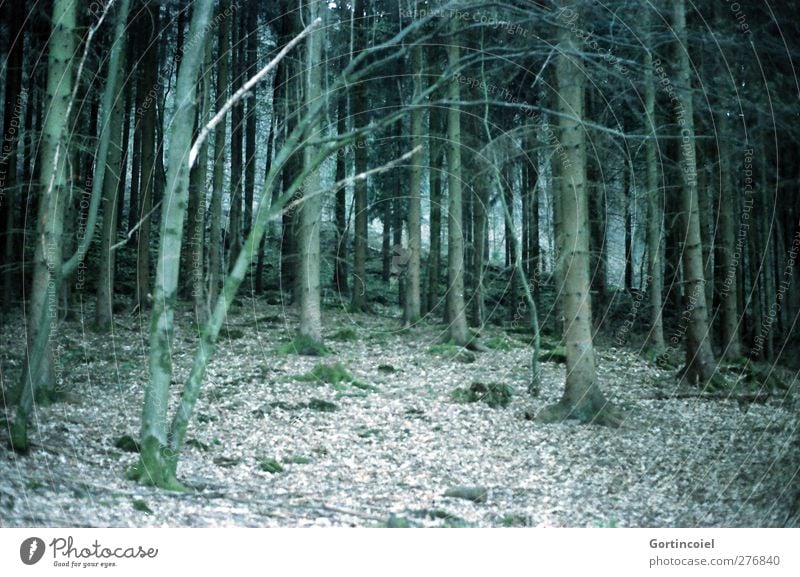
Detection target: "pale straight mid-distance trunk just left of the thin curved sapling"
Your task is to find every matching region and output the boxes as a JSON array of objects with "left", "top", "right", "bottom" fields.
[{"left": 447, "top": 19, "right": 470, "bottom": 347}]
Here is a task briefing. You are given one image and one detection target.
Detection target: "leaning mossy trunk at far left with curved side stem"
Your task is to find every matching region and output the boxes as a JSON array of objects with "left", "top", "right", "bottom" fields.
[{"left": 10, "top": 0, "right": 129, "bottom": 452}]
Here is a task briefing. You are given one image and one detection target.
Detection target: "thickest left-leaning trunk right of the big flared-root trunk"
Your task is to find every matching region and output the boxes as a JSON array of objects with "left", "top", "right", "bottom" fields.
[{"left": 673, "top": 0, "right": 715, "bottom": 383}]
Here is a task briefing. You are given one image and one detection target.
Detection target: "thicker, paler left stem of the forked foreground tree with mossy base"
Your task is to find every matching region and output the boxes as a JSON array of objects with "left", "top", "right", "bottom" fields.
[{"left": 133, "top": 0, "right": 214, "bottom": 488}]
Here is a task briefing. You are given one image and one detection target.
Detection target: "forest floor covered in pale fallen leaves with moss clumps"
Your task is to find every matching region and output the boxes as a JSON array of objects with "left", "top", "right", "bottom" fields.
[{"left": 0, "top": 299, "right": 800, "bottom": 527}]
